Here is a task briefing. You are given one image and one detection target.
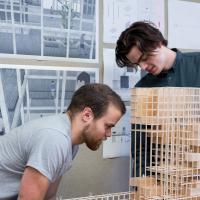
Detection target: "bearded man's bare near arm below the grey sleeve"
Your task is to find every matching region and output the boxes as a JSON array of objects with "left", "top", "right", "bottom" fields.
[{"left": 18, "top": 167, "right": 50, "bottom": 200}]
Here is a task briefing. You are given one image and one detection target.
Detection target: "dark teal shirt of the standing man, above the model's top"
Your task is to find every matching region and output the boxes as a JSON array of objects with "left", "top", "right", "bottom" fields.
[{"left": 135, "top": 49, "right": 200, "bottom": 87}]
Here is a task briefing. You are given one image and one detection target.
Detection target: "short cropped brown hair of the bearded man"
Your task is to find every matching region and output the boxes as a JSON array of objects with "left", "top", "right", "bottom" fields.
[{"left": 67, "top": 83, "right": 126, "bottom": 119}]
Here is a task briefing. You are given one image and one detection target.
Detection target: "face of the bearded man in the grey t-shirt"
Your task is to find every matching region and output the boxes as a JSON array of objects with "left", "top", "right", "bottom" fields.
[{"left": 83, "top": 104, "right": 122, "bottom": 151}]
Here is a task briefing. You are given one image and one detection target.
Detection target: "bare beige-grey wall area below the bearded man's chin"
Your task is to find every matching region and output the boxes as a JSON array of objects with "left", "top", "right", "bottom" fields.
[{"left": 58, "top": 145, "right": 129, "bottom": 198}]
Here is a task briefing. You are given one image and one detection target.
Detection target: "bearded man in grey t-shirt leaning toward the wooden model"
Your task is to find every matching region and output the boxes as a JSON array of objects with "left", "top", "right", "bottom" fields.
[{"left": 0, "top": 84, "right": 126, "bottom": 200}]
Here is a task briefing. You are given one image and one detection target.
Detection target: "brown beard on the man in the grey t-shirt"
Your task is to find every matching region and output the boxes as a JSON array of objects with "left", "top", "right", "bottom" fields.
[{"left": 83, "top": 126, "right": 102, "bottom": 151}]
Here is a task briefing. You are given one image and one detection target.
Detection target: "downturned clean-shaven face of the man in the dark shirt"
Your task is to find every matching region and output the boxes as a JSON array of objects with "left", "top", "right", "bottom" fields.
[{"left": 126, "top": 45, "right": 166, "bottom": 75}]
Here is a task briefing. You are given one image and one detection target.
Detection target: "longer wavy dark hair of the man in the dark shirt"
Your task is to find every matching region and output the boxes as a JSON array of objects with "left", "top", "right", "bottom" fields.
[{"left": 115, "top": 21, "right": 167, "bottom": 67}]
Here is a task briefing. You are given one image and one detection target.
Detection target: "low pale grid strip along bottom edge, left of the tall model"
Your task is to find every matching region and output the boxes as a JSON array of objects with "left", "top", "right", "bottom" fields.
[{"left": 62, "top": 192, "right": 134, "bottom": 200}]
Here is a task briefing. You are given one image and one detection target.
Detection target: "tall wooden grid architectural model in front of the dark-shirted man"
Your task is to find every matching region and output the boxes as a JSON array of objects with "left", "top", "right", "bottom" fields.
[{"left": 130, "top": 87, "right": 200, "bottom": 200}]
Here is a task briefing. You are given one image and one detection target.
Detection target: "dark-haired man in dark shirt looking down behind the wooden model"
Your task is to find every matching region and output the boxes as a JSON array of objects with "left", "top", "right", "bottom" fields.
[{"left": 115, "top": 22, "right": 200, "bottom": 176}]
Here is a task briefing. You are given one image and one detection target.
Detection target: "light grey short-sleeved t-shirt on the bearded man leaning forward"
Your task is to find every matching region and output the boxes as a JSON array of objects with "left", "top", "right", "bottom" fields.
[{"left": 0, "top": 114, "right": 78, "bottom": 198}]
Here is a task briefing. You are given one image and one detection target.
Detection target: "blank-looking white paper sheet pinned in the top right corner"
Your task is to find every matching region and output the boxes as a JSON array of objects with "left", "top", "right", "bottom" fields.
[{"left": 168, "top": 0, "right": 200, "bottom": 50}]
